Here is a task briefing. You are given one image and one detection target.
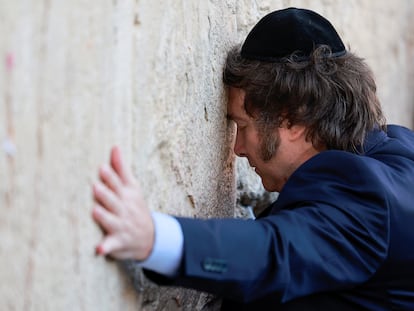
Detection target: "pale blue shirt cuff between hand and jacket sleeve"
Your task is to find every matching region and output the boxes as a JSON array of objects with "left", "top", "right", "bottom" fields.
[{"left": 138, "top": 212, "right": 184, "bottom": 277}]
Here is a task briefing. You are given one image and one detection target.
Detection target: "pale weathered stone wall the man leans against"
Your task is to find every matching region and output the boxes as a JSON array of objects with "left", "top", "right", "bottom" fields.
[{"left": 0, "top": 0, "right": 414, "bottom": 310}]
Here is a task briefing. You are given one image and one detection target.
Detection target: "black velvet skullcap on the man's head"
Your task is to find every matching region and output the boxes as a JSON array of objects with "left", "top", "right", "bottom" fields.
[{"left": 241, "top": 8, "right": 346, "bottom": 62}]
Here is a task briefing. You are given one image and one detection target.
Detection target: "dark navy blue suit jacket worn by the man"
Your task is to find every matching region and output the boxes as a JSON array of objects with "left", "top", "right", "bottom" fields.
[{"left": 147, "top": 126, "right": 414, "bottom": 310}]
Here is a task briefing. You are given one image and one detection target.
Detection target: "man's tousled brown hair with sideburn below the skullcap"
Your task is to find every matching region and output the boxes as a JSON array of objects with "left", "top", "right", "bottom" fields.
[{"left": 223, "top": 46, "right": 385, "bottom": 152}]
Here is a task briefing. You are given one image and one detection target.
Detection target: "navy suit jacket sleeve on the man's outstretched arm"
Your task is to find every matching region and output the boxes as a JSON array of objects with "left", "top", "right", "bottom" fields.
[{"left": 145, "top": 153, "right": 388, "bottom": 302}]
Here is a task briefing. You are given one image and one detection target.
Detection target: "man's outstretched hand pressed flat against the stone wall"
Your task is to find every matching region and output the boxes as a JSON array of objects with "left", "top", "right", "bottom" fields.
[{"left": 92, "top": 147, "right": 154, "bottom": 260}]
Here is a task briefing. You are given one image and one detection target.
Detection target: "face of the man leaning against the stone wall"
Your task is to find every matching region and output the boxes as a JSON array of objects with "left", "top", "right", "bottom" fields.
[{"left": 227, "top": 87, "right": 316, "bottom": 191}]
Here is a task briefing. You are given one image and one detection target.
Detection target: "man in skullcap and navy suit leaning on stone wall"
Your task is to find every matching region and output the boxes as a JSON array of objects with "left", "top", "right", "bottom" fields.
[{"left": 93, "top": 8, "right": 414, "bottom": 310}]
